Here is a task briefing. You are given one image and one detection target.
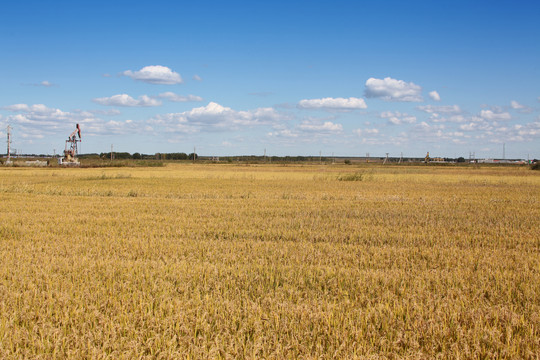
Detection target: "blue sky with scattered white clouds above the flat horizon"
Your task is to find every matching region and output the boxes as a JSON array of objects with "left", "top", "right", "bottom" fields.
[{"left": 0, "top": 1, "right": 540, "bottom": 158}]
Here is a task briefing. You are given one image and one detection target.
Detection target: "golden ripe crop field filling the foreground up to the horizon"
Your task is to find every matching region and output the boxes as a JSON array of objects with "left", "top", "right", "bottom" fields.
[{"left": 0, "top": 164, "right": 540, "bottom": 359}]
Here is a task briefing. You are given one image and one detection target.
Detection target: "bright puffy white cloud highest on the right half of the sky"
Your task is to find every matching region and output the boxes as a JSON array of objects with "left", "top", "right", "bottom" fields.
[{"left": 365, "top": 77, "right": 423, "bottom": 102}]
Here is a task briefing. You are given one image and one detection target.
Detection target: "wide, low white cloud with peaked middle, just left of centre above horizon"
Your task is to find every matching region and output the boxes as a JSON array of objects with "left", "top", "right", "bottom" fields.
[{"left": 149, "top": 102, "right": 284, "bottom": 133}]
